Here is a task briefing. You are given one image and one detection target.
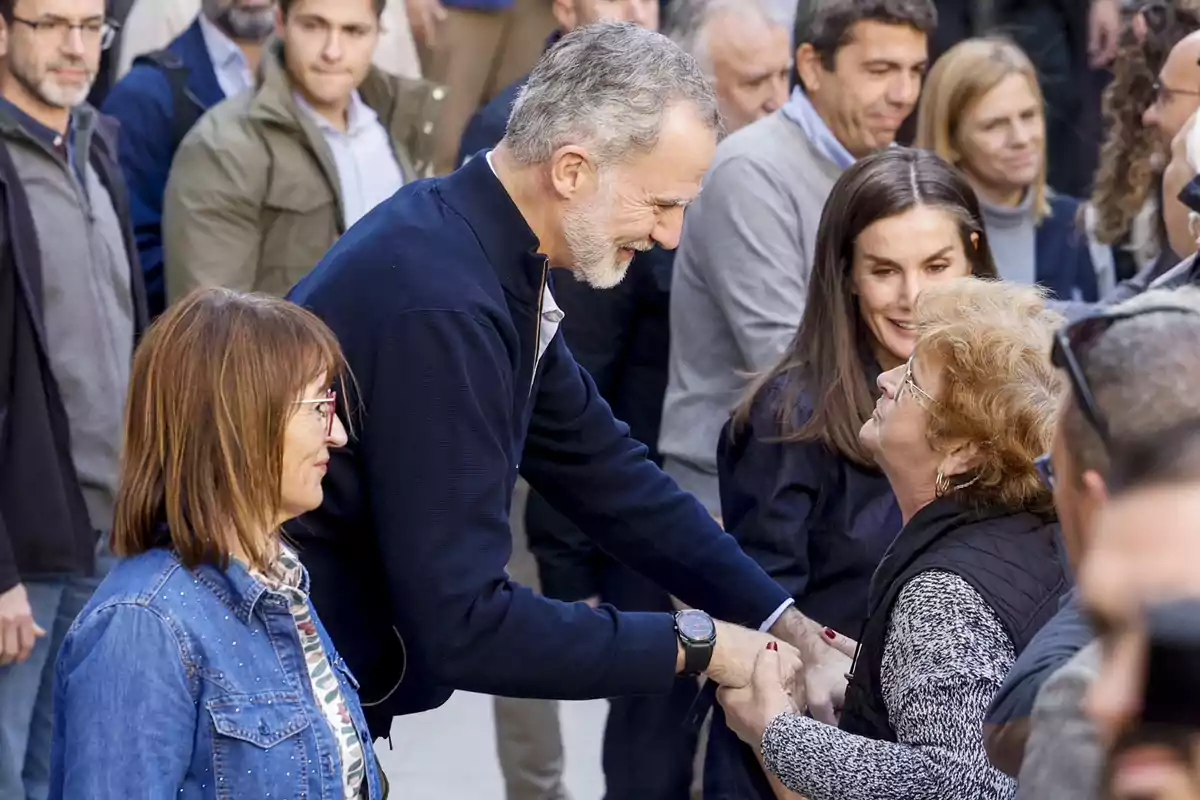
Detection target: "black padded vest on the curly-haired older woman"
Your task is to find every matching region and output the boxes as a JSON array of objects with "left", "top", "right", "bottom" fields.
[{"left": 840, "top": 498, "right": 1068, "bottom": 741}]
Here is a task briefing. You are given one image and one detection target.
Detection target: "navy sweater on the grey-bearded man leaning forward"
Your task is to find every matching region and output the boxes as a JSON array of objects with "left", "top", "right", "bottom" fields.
[{"left": 280, "top": 153, "right": 788, "bottom": 712}]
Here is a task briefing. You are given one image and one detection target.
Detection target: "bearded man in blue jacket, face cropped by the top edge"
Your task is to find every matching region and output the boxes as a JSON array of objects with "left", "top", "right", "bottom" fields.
[{"left": 104, "top": 0, "right": 275, "bottom": 314}]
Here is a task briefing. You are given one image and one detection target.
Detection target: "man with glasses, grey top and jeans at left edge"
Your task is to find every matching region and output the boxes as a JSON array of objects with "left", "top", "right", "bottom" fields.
[{"left": 0, "top": 0, "right": 145, "bottom": 798}]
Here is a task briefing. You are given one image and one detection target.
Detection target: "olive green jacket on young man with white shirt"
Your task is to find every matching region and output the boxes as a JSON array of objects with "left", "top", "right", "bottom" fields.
[{"left": 162, "top": 42, "right": 445, "bottom": 302}]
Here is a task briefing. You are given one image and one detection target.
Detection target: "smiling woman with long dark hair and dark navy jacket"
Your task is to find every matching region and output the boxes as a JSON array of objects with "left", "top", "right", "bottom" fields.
[{"left": 704, "top": 148, "right": 996, "bottom": 800}]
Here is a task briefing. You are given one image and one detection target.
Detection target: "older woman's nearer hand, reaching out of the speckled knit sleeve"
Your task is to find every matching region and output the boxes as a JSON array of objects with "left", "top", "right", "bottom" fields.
[{"left": 716, "top": 642, "right": 805, "bottom": 752}]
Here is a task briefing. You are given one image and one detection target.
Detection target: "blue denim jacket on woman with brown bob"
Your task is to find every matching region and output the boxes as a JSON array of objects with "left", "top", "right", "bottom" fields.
[{"left": 50, "top": 549, "right": 383, "bottom": 800}]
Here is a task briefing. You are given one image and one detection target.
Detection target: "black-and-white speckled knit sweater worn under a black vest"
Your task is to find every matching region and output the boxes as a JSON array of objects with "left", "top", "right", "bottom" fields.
[{"left": 762, "top": 571, "right": 1016, "bottom": 800}]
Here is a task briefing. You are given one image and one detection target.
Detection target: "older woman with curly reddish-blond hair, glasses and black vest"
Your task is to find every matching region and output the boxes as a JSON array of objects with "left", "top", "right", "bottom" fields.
[{"left": 719, "top": 278, "right": 1068, "bottom": 800}]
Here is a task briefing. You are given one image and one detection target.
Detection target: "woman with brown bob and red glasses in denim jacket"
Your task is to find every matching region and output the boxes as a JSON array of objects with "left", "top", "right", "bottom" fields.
[{"left": 50, "top": 289, "right": 384, "bottom": 800}]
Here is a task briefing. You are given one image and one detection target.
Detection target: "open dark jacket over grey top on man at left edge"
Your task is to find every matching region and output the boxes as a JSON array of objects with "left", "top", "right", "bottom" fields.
[{"left": 0, "top": 107, "right": 146, "bottom": 593}]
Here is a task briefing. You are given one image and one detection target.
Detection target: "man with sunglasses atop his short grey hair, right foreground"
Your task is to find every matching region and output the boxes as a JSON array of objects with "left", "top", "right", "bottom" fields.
[{"left": 985, "top": 288, "right": 1200, "bottom": 800}]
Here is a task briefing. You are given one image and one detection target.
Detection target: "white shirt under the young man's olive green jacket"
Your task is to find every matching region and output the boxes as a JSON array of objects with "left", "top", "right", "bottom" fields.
[{"left": 295, "top": 92, "right": 404, "bottom": 228}]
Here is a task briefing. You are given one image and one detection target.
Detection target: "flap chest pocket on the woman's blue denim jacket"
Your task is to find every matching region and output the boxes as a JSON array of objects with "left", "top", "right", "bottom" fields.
[{"left": 205, "top": 692, "right": 320, "bottom": 800}]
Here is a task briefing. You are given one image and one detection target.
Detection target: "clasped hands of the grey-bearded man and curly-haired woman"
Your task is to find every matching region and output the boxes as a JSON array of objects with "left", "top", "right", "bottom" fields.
[{"left": 707, "top": 625, "right": 857, "bottom": 751}]
